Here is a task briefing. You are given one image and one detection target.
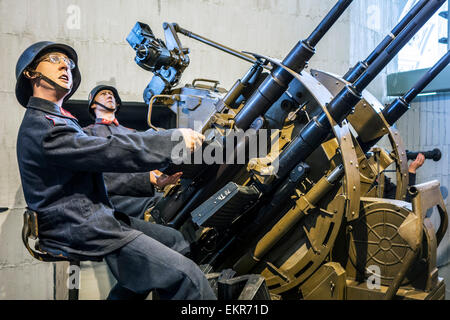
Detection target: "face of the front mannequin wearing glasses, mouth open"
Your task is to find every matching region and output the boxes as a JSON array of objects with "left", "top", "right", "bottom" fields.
[{"left": 35, "top": 52, "right": 73, "bottom": 89}]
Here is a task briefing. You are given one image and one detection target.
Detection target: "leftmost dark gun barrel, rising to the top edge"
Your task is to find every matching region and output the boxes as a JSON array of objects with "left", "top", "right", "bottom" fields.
[{"left": 235, "top": 0, "right": 353, "bottom": 130}]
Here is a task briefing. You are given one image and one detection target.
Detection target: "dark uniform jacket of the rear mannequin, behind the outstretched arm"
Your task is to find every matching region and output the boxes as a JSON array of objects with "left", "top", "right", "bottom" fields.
[{"left": 83, "top": 118, "right": 157, "bottom": 219}]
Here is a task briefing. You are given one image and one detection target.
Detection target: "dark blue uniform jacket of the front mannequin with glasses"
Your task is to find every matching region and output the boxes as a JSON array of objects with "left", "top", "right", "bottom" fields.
[{"left": 17, "top": 97, "right": 178, "bottom": 256}]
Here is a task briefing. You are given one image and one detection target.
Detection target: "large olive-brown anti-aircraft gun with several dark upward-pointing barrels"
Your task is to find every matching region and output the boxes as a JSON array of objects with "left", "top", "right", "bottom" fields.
[{"left": 128, "top": 0, "right": 450, "bottom": 299}]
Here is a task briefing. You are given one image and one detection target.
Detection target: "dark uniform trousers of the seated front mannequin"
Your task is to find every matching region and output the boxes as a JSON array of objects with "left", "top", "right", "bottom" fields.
[{"left": 105, "top": 213, "right": 216, "bottom": 300}]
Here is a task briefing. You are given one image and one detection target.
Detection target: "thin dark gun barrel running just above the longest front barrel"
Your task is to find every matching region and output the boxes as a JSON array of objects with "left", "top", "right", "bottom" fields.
[{"left": 344, "top": 0, "right": 428, "bottom": 82}]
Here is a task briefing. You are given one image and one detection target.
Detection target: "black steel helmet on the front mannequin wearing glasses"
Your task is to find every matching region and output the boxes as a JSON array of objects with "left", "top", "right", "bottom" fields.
[{"left": 16, "top": 41, "right": 81, "bottom": 107}]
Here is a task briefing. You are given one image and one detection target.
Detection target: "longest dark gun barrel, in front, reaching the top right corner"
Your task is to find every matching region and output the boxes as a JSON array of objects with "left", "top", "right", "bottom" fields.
[{"left": 278, "top": 0, "right": 445, "bottom": 180}]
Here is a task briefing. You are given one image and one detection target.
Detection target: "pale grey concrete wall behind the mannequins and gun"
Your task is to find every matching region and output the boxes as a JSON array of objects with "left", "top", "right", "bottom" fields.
[{"left": 0, "top": 0, "right": 403, "bottom": 299}]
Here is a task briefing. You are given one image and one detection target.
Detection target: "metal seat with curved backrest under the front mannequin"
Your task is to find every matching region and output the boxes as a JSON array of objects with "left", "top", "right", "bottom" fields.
[{"left": 22, "top": 208, "right": 102, "bottom": 300}]
